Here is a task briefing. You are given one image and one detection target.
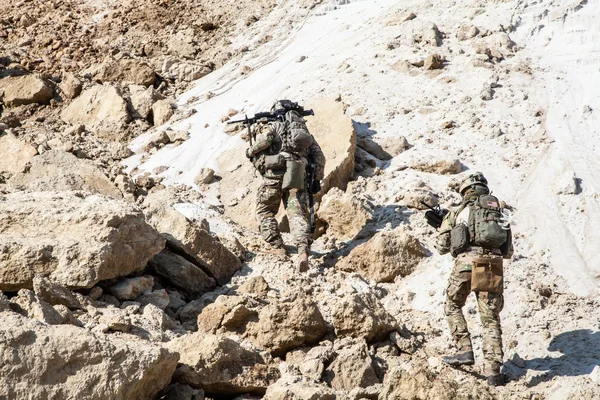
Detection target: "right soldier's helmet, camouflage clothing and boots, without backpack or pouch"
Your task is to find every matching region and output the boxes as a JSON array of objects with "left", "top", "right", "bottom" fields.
[{"left": 435, "top": 173, "right": 513, "bottom": 386}]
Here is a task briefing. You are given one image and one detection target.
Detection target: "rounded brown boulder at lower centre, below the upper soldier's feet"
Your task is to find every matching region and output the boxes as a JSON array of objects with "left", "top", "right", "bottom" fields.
[{"left": 247, "top": 294, "right": 327, "bottom": 356}]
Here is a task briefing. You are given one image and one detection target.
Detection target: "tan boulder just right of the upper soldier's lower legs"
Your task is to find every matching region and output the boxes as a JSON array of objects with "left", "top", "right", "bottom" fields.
[{"left": 317, "top": 188, "right": 373, "bottom": 241}]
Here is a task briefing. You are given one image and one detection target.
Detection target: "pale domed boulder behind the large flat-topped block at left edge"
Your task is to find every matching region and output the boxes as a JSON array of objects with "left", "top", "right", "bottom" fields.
[{"left": 8, "top": 150, "right": 123, "bottom": 198}]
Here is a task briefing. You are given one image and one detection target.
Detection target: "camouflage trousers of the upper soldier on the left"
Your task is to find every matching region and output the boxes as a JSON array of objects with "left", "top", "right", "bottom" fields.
[{"left": 256, "top": 178, "right": 312, "bottom": 253}]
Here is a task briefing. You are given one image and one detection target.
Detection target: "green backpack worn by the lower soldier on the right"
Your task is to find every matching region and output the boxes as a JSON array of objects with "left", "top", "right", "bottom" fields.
[{"left": 468, "top": 194, "right": 508, "bottom": 249}]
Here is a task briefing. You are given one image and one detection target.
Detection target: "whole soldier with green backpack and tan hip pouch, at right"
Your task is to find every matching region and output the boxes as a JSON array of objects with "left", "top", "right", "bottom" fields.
[{"left": 435, "top": 172, "right": 513, "bottom": 386}]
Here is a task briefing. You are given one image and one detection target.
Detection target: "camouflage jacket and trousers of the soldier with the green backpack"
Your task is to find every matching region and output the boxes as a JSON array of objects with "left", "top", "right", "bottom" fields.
[{"left": 435, "top": 192, "right": 513, "bottom": 375}]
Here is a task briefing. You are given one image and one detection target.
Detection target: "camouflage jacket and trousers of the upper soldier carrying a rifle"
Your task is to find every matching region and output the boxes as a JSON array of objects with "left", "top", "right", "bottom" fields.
[{"left": 247, "top": 121, "right": 325, "bottom": 253}]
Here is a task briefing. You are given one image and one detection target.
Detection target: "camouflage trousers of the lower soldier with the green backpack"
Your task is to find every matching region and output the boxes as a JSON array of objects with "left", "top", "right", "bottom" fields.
[{"left": 444, "top": 254, "right": 504, "bottom": 372}]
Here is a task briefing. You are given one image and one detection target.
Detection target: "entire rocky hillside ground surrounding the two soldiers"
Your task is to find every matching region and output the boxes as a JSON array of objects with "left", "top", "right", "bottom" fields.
[{"left": 0, "top": 0, "right": 600, "bottom": 400}]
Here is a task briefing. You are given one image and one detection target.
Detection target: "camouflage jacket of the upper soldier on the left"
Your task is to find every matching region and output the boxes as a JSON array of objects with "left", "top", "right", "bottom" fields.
[{"left": 247, "top": 121, "right": 325, "bottom": 180}]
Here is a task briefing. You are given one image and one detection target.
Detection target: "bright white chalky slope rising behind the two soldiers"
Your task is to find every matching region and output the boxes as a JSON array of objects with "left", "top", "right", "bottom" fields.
[{"left": 129, "top": 0, "right": 600, "bottom": 399}]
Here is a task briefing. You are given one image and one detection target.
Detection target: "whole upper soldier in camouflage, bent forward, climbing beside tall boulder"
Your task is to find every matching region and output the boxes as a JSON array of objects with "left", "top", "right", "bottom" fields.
[{"left": 246, "top": 100, "right": 325, "bottom": 272}]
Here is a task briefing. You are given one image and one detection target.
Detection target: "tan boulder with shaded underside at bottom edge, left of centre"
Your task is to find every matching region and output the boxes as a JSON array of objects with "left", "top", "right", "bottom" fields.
[{"left": 167, "top": 332, "right": 279, "bottom": 395}]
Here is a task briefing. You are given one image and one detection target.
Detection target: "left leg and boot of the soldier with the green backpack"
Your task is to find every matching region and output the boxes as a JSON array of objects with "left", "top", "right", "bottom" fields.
[{"left": 444, "top": 262, "right": 475, "bottom": 365}]
